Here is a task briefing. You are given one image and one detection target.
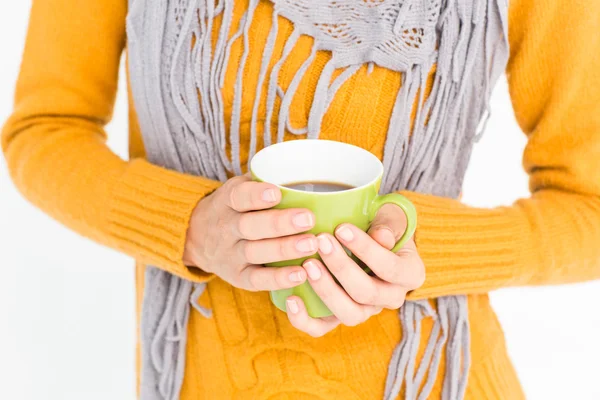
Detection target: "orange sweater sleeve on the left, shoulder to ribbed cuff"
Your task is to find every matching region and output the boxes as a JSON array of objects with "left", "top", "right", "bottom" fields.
[{"left": 2, "top": 0, "right": 219, "bottom": 281}]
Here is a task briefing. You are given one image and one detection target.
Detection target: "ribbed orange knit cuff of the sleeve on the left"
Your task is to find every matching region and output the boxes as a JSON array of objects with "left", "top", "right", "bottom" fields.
[{"left": 108, "top": 159, "right": 221, "bottom": 282}]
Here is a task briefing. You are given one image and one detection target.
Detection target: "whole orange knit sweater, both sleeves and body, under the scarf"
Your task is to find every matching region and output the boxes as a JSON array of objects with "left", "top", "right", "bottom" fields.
[{"left": 2, "top": 0, "right": 600, "bottom": 399}]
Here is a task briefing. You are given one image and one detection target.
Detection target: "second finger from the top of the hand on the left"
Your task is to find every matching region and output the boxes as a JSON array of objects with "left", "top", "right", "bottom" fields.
[{"left": 236, "top": 208, "right": 315, "bottom": 240}]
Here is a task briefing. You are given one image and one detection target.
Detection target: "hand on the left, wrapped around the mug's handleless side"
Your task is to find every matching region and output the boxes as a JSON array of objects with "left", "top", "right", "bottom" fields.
[{"left": 183, "top": 175, "right": 318, "bottom": 291}]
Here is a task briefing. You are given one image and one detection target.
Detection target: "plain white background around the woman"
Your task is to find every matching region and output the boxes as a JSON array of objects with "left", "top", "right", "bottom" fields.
[{"left": 0, "top": 0, "right": 600, "bottom": 400}]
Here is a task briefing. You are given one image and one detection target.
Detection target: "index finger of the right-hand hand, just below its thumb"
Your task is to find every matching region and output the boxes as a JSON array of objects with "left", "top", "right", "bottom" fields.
[{"left": 336, "top": 224, "right": 425, "bottom": 290}]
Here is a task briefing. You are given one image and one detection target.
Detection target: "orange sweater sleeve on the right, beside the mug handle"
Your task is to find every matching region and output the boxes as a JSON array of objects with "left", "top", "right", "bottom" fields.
[{"left": 406, "top": 0, "right": 600, "bottom": 298}]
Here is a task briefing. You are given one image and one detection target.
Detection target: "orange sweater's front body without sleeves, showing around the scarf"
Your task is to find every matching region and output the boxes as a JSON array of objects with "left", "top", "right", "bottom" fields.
[{"left": 131, "top": 1, "right": 522, "bottom": 400}]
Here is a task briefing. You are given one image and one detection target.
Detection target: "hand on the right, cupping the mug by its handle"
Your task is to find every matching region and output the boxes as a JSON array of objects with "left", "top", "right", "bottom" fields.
[{"left": 286, "top": 204, "right": 425, "bottom": 337}]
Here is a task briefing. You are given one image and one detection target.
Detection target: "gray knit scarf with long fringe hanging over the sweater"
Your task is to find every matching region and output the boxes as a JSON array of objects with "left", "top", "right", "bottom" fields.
[{"left": 127, "top": 0, "right": 508, "bottom": 400}]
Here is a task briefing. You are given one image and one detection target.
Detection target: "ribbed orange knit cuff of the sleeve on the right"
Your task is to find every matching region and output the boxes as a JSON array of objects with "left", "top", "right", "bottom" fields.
[{"left": 402, "top": 192, "right": 533, "bottom": 299}]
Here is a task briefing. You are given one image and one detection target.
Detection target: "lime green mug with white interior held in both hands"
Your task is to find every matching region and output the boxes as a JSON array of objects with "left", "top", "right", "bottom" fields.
[{"left": 250, "top": 139, "right": 417, "bottom": 318}]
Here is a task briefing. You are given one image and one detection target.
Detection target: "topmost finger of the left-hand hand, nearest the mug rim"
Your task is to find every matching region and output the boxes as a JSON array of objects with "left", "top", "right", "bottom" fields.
[{"left": 224, "top": 175, "right": 281, "bottom": 212}]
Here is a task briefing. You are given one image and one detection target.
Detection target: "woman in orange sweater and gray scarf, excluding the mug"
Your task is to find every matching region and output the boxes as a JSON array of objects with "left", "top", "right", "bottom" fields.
[{"left": 2, "top": 0, "right": 600, "bottom": 399}]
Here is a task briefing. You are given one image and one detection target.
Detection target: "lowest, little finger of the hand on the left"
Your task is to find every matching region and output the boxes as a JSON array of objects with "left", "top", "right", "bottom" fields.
[{"left": 238, "top": 265, "right": 306, "bottom": 291}]
